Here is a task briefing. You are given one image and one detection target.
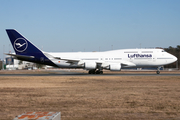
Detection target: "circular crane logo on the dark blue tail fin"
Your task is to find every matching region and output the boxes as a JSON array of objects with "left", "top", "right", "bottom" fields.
[{"left": 14, "top": 38, "right": 28, "bottom": 52}]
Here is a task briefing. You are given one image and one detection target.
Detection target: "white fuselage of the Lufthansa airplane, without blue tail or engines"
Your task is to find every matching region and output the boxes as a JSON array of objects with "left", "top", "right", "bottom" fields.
[{"left": 48, "top": 49, "right": 177, "bottom": 68}]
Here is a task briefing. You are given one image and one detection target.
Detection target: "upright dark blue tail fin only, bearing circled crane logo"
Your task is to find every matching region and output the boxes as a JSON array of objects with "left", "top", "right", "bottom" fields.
[{"left": 6, "top": 29, "right": 42, "bottom": 56}]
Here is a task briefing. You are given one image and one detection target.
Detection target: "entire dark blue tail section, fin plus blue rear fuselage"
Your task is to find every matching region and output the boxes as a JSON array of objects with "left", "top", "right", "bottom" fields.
[{"left": 6, "top": 29, "right": 57, "bottom": 67}]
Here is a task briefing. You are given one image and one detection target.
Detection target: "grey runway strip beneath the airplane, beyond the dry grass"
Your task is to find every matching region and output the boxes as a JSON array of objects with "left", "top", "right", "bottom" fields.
[{"left": 0, "top": 70, "right": 180, "bottom": 76}]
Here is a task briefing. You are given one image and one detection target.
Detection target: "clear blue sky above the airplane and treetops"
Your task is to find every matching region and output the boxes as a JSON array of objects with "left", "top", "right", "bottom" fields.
[{"left": 0, "top": 0, "right": 180, "bottom": 59}]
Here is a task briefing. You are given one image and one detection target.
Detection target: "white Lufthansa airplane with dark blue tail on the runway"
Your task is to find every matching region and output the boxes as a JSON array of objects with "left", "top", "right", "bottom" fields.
[{"left": 6, "top": 29, "right": 177, "bottom": 74}]
